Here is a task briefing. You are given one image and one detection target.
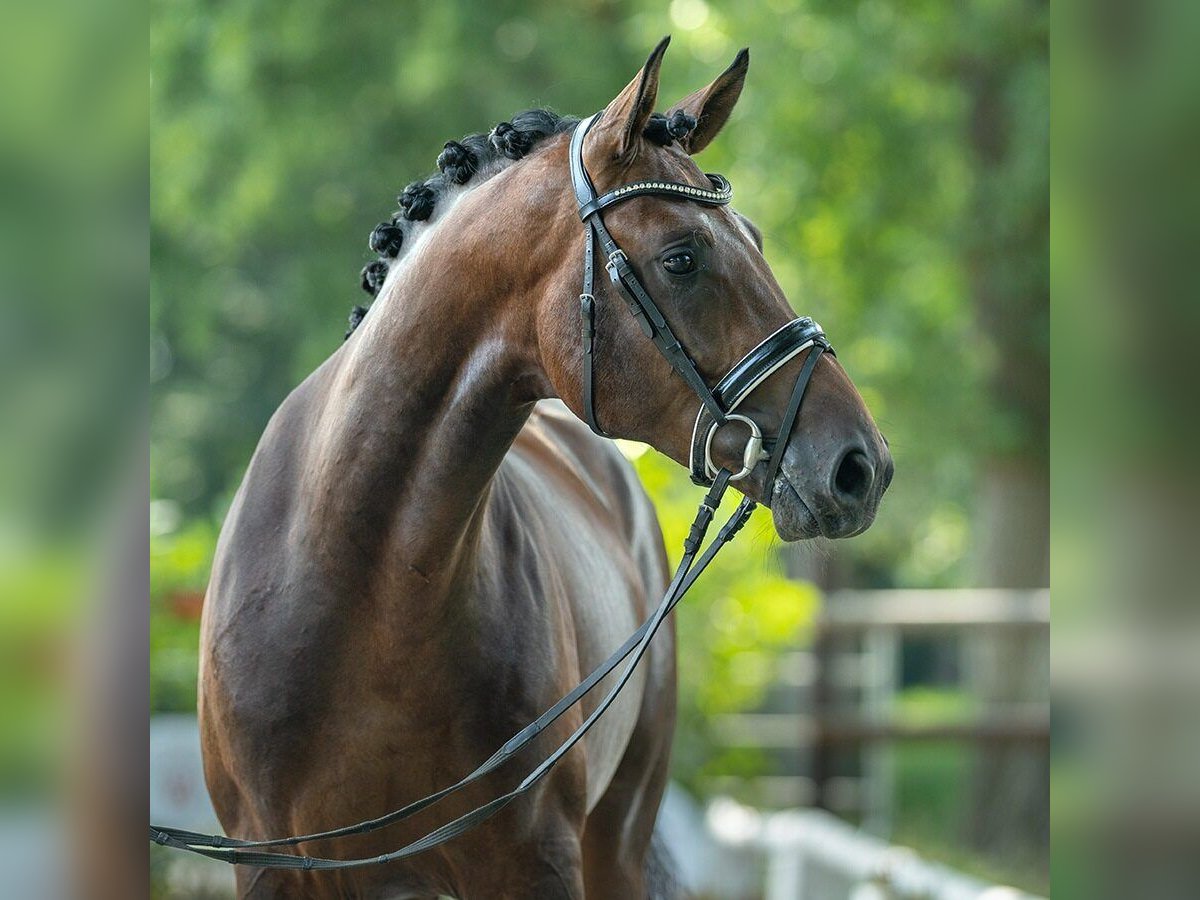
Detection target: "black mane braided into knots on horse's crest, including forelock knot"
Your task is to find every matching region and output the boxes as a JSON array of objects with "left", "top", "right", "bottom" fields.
[{"left": 343, "top": 109, "right": 696, "bottom": 340}]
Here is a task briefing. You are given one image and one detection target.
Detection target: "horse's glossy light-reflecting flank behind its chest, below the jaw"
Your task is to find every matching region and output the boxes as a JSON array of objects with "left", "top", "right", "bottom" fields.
[{"left": 487, "top": 401, "right": 674, "bottom": 809}]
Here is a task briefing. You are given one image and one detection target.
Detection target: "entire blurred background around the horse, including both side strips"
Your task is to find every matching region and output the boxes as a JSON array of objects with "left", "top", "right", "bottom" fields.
[{"left": 37, "top": 0, "right": 1200, "bottom": 900}]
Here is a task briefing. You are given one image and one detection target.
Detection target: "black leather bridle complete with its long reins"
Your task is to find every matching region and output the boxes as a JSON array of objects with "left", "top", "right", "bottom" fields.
[{"left": 150, "top": 113, "right": 833, "bottom": 870}]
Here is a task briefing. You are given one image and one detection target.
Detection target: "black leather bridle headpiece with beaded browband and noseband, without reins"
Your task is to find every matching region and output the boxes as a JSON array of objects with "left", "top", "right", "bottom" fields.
[{"left": 570, "top": 113, "right": 833, "bottom": 493}]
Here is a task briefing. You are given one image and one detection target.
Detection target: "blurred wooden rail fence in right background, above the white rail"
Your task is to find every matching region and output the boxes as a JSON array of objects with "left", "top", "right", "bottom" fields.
[{"left": 706, "top": 588, "right": 1050, "bottom": 839}]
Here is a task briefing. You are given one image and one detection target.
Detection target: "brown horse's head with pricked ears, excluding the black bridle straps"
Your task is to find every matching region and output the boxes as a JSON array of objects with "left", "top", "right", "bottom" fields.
[{"left": 539, "top": 41, "right": 893, "bottom": 540}]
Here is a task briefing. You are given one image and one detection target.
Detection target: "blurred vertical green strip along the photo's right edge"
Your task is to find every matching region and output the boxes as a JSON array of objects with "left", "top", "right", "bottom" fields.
[{"left": 1051, "top": 0, "right": 1200, "bottom": 900}]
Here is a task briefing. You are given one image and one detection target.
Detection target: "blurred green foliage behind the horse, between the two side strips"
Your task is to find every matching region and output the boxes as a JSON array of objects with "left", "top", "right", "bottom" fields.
[{"left": 150, "top": 0, "right": 1049, "bottom": 889}]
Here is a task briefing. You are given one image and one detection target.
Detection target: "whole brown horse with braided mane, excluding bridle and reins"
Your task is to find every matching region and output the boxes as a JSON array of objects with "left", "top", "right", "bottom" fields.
[{"left": 198, "top": 41, "right": 893, "bottom": 900}]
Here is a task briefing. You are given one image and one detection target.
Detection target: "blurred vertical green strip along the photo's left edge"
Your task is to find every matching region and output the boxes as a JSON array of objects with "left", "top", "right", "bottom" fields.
[{"left": 0, "top": 0, "right": 149, "bottom": 900}]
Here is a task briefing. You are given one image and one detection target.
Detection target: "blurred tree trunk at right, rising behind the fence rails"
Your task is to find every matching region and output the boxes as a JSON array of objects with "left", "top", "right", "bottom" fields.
[{"left": 948, "top": 0, "right": 1050, "bottom": 858}]
